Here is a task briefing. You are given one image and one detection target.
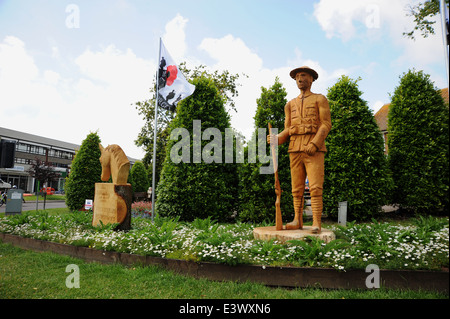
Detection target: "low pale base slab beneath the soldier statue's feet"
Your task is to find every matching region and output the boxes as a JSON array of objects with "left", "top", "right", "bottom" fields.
[{"left": 253, "top": 226, "right": 336, "bottom": 243}]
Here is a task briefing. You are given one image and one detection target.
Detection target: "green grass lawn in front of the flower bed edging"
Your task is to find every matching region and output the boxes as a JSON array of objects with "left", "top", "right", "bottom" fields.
[{"left": 0, "top": 243, "right": 448, "bottom": 299}]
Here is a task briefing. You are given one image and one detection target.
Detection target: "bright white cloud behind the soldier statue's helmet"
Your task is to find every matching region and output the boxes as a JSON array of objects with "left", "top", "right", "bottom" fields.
[{"left": 199, "top": 35, "right": 347, "bottom": 140}]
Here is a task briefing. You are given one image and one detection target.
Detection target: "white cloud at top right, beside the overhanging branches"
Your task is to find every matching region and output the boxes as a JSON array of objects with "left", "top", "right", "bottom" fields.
[{"left": 314, "top": 0, "right": 444, "bottom": 68}]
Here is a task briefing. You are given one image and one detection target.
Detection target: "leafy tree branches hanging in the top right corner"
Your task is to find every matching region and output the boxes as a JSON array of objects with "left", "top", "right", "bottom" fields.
[{"left": 403, "top": 0, "right": 449, "bottom": 42}]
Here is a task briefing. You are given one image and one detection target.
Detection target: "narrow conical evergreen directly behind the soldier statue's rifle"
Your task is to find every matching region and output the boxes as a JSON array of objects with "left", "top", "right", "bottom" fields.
[{"left": 239, "top": 77, "right": 294, "bottom": 222}]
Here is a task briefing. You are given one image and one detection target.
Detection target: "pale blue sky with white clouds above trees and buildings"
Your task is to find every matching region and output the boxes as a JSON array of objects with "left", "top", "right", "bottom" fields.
[{"left": 0, "top": 0, "right": 448, "bottom": 159}]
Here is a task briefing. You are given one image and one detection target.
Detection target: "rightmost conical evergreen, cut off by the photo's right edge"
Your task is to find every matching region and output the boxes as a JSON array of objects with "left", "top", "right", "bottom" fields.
[{"left": 388, "top": 70, "right": 449, "bottom": 213}]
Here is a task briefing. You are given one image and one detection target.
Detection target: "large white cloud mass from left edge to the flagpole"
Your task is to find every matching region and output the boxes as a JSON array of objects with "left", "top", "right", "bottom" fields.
[{"left": 0, "top": 37, "right": 156, "bottom": 158}]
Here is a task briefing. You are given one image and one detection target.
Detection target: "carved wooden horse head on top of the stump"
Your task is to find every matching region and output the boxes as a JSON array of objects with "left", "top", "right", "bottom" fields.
[{"left": 99, "top": 144, "right": 130, "bottom": 185}]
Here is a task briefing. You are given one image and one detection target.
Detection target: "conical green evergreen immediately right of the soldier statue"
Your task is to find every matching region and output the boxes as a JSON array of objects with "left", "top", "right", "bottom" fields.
[{"left": 324, "top": 76, "right": 392, "bottom": 219}]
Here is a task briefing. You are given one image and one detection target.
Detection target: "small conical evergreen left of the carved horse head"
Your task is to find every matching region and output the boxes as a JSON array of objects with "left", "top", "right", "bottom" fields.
[{"left": 65, "top": 133, "right": 102, "bottom": 210}]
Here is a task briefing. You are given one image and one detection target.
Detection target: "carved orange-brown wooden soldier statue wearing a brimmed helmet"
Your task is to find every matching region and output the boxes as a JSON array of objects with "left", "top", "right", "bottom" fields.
[{"left": 267, "top": 66, "right": 331, "bottom": 233}]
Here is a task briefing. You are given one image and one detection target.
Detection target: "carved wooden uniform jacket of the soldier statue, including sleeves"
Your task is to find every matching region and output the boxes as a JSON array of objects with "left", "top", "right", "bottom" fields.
[{"left": 278, "top": 93, "right": 331, "bottom": 153}]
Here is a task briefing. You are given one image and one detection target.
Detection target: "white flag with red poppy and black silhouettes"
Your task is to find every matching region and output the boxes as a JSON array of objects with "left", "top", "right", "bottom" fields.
[{"left": 158, "top": 40, "right": 195, "bottom": 111}]
